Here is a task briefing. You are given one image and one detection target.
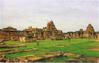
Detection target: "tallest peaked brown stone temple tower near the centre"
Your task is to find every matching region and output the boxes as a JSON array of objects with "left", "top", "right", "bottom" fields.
[{"left": 43, "top": 21, "right": 63, "bottom": 39}]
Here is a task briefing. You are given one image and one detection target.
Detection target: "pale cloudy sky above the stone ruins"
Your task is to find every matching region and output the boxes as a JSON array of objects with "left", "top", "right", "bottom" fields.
[{"left": 0, "top": 0, "right": 99, "bottom": 32}]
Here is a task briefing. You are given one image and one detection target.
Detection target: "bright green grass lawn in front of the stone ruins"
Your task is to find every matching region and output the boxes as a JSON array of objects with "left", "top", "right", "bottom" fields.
[{"left": 0, "top": 39, "right": 99, "bottom": 59}]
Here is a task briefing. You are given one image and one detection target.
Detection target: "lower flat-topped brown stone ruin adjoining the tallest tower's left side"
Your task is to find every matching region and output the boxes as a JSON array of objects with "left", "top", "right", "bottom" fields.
[{"left": 24, "top": 27, "right": 43, "bottom": 40}]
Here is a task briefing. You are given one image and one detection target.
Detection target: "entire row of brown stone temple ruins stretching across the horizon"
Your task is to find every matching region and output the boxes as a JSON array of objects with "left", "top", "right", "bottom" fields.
[{"left": 0, "top": 21, "right": 99, "bottom": 42}]
